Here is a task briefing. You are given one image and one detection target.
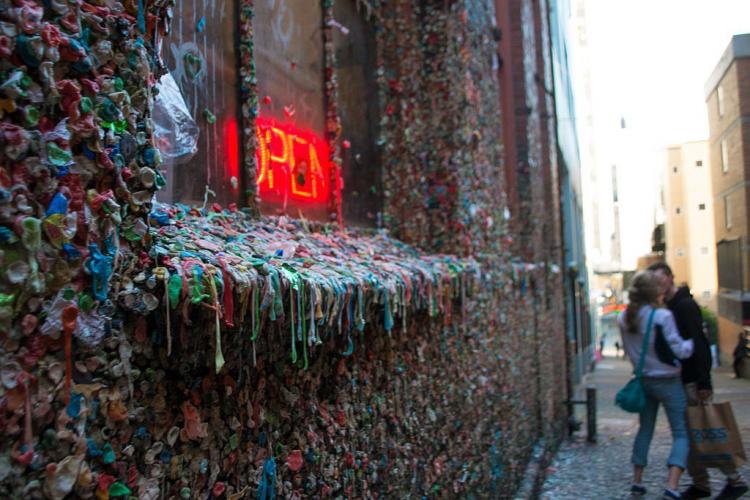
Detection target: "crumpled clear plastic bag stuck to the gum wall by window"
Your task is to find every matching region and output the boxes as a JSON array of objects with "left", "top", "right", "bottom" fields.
[{"left": 152, "top": 73, "right": 200, "bottom": 165}]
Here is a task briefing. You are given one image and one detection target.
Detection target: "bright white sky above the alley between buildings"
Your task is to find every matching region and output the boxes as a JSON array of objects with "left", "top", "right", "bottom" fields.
[{"left": 570, "top": 0, "right": 750, "bottom": 269}]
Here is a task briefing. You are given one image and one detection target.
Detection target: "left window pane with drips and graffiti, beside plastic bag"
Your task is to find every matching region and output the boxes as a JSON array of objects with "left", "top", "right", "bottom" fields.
[{"left": 159, "top": 0, "right": 241, "bottom": 205}]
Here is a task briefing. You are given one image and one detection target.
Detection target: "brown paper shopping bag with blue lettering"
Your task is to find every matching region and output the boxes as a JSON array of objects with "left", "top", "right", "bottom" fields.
[{"left": 687, "top": 402, "right": 747, "bottom": 468}]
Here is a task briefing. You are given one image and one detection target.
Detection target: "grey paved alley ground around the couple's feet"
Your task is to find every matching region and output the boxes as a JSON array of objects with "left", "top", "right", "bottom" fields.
[{"left": 541, "top": 357, "right": 750, "bottom": 500}]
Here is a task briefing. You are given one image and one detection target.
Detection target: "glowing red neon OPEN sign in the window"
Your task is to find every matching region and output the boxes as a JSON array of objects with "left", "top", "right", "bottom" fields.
[{"left": 255, "top": 117, "right": 331, "bottom": 205}]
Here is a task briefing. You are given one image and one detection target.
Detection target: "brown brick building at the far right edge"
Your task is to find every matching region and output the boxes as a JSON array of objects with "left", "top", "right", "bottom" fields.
[{"left": 705, "top": 34, "right": 750, "bottom": 356}]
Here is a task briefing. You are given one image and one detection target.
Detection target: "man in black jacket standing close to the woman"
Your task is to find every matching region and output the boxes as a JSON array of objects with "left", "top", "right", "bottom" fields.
[{"left": 649, "top": 262, "right": 748, "bottom": 500}]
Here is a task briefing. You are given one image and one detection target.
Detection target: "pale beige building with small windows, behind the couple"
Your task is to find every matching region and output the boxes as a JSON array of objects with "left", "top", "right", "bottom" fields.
[{"left": 664, "top": 141, "right": 716, "bottom": 310}]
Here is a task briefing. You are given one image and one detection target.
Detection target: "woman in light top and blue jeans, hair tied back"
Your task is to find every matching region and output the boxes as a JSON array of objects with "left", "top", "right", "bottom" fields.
[{"left": 618, "top": 271, "right": 693, "bottom": 499}]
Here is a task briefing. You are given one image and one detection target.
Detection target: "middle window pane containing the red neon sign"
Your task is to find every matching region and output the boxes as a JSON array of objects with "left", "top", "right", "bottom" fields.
[{"left": 253, "top": 0, "right": 333, "bottom": 219}]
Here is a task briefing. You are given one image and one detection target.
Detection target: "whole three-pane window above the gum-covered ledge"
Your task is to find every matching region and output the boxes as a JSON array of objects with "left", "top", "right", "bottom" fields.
[{"left": 159, "top": 0, "right": 382, "bottom": 225}]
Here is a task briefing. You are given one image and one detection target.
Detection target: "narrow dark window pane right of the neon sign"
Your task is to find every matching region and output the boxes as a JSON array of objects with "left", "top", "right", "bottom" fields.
[{"left": 333, "top": 0, "right": 382, "bottom": 226}]
